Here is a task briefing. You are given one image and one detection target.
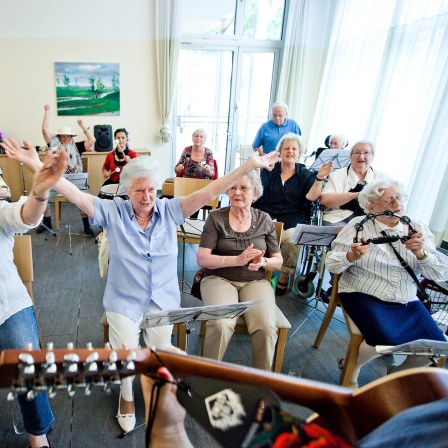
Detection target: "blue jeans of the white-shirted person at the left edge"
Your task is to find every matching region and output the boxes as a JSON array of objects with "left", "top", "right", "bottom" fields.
[{"left": 0, "top": 306, "right": 54, "bottom": 436}]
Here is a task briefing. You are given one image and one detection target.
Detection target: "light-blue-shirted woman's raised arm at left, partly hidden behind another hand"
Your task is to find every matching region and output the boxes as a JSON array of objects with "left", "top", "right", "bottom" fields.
[{"left": 0, "top": 138, "right": 94, "bottom": 217}]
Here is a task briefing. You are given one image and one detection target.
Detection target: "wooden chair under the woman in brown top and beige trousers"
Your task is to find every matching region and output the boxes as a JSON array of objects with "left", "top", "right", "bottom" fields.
[{"left": 200, "top": 222, "right": 291, "bottom": 373}]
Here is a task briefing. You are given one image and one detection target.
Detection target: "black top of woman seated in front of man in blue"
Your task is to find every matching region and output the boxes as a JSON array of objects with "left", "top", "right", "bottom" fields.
[{"left": 253, "top": 162, "right": 316, "bottom": 230}]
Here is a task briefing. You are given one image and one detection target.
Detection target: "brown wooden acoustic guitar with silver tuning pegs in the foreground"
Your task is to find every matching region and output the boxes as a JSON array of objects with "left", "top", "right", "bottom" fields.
[{"left": 0, "top": 347, "right": 448, "bottom": 443}]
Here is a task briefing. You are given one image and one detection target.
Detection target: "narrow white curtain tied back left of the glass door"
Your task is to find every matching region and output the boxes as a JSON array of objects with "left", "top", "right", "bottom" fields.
[{"left": 154, "top": 0, "right": 182, "bottom": 143}]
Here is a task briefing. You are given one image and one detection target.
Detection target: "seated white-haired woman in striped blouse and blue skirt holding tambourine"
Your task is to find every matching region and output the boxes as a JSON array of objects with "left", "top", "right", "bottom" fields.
[{"left": 326, "top": 179, "right": 448, "bottom": 387}]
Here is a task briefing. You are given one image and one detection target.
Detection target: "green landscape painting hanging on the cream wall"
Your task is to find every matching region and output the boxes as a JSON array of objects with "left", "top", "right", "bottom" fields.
[{"left": 54, "top": 62, "right": 120, "bottom": 115}]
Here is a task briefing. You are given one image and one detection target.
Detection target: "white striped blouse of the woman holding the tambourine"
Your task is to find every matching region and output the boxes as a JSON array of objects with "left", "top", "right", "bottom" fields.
[{"left": 325, "top": 216, "right": 448, "bottom": 303}]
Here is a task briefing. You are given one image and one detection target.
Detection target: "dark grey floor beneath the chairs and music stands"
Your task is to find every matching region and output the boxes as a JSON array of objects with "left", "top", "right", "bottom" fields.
[{"left": 0, "top": 203, "right": 391, "bottom": 448}]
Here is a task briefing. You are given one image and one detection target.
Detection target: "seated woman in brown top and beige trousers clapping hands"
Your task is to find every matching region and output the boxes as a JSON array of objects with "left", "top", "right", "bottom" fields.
[{"left": 198, "top": 171, "right": 283, "bottom": 370}]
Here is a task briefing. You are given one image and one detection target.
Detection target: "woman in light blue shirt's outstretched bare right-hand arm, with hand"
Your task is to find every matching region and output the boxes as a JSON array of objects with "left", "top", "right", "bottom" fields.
[{"left": 181, "top": 151, "right": 280, "bottom": 218}]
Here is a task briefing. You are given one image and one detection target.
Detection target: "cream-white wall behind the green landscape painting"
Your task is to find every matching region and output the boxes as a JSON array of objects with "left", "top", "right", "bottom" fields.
[{"left": 0, "top": 0, "right": 172, "bottom": 177}]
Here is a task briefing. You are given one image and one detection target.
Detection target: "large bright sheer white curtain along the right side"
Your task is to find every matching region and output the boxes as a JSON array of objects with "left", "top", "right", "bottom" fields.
[{"left": 309, "top": 0, "right": 448, "bottom": 242}]
